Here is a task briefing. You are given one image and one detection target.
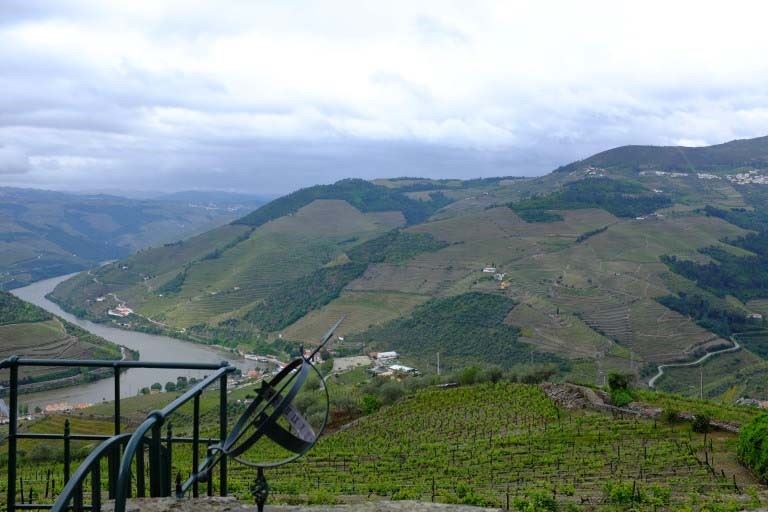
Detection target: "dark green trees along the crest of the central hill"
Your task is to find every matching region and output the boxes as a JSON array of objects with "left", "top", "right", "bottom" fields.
[{"left": 234, "top": 179, "right": 452, "bottom": 227}]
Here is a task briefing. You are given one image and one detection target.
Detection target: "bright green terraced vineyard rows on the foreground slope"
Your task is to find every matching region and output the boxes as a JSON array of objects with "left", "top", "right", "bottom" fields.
[{"left": 7, "top": 382, "right": 766, "bottom": 511}]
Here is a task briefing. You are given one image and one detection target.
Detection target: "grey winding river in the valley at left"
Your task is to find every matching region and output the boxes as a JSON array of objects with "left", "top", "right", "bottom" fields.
[{"left": 11, "top": 274, "right": 258, "bottom": 410}]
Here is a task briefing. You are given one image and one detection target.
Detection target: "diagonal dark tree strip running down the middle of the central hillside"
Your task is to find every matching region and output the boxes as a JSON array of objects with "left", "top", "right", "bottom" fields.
[{"left": 245, "top": 230, "right": 447, "bottom": 331}]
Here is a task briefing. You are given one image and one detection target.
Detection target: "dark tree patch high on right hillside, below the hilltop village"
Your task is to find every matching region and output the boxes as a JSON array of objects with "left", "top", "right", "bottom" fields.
[{"left": 508, "top": 178, "right": 672, "bottom": 222}]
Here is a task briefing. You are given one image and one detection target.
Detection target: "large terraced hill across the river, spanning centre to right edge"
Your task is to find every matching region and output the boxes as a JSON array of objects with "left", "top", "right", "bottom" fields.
[{"left": 52, "top": 138, "right": 768, "bottom": 399}]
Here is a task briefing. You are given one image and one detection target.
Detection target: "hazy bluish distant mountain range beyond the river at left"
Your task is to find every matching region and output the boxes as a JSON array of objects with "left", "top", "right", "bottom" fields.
[{"left": 0, "top": 187, "right": 263, "bottom": 290}]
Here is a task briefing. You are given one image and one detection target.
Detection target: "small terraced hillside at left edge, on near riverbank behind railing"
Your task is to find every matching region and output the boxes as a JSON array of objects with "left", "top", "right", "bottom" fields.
[{"left": 0, "top": 292, "right": 122, "bottom": 386}]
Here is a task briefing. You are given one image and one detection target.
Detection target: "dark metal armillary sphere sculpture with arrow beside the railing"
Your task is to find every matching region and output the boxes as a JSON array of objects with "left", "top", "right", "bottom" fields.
[{"left": 176, "top": 318, "right": 344, "bottom": 512}]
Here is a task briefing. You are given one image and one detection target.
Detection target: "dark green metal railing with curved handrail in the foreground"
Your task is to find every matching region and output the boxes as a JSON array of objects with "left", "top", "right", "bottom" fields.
[{"left": 0, "top": 356, "right": 235, "bottom": 512}]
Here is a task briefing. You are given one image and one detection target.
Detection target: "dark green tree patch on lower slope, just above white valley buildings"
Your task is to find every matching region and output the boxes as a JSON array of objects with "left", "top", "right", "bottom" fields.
[{"left": 353, "top": 292, "right": 561, "bottom": 368}]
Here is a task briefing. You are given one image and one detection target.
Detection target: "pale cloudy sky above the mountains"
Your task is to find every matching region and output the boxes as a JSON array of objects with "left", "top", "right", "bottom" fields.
[{"left": 0, "top": 0, "right": 768, "bottom": 194}]
